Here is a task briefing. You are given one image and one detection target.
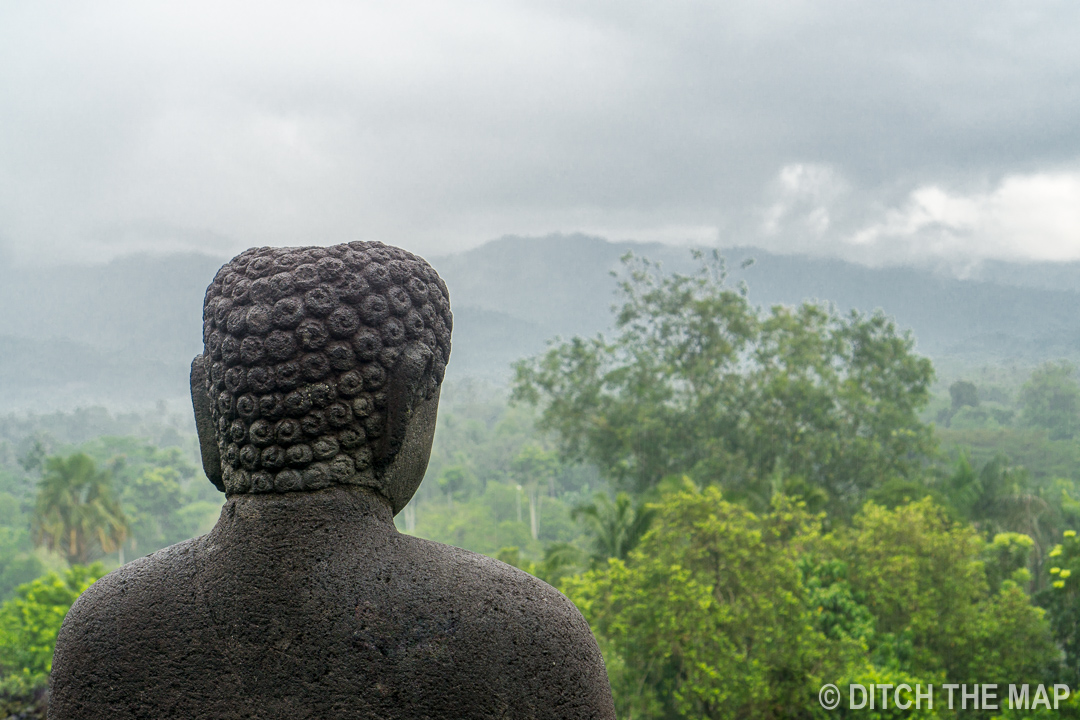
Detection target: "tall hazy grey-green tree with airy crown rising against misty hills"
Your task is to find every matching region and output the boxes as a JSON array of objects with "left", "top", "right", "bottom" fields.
[{"left": 513, "top": 255, "right": 935, "bottom": 513}]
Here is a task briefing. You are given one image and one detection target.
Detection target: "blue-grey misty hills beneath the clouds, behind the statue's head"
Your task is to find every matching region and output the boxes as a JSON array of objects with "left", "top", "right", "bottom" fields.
[{"left": 0, "top": 235, "right": 1080, "bottom": 411}]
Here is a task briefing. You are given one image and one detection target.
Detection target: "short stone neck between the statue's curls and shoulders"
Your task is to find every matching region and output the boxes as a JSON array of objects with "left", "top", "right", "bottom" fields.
[{"left": 211, "top": 486, "right": 397, "bottom": 548}]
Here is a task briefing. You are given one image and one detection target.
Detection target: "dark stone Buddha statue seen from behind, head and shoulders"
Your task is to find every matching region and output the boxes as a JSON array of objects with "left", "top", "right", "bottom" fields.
[{"left": 50, "top": 243, "right": 615, "bottom": 720}]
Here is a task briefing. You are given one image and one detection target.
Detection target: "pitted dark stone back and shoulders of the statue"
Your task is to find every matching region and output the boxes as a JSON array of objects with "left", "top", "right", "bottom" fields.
[{"left": 51, "top": 489, "right": 613, "bottom": 720}]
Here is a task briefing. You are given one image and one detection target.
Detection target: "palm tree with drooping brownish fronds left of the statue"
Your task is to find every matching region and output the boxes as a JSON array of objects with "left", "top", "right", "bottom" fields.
[{"left": 35, "top": 452, "right": 127, "bottom": 565}]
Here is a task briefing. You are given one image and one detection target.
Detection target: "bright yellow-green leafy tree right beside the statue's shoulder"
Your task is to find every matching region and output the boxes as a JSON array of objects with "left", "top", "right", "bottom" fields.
[{"left": 564, "top": 487, "right": 847, "bottom": 718}]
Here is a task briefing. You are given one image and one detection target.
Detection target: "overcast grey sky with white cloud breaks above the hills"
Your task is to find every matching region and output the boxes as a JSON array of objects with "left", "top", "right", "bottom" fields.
[{"left": 0, "top": 0, "right": 1080, "bottom": 268}]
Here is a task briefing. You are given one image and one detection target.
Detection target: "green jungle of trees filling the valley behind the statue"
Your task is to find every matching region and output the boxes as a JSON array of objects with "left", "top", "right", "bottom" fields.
[{"left": 0, "top": 257, "right": 1080, "bottom": 719}]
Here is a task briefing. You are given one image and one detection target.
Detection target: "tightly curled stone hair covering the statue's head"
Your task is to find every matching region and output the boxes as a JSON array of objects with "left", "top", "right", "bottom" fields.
[{"left": 192, "top": 242, "right": 451, "bottom": 510}]
